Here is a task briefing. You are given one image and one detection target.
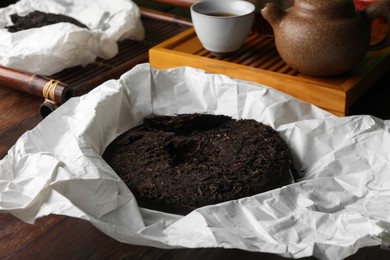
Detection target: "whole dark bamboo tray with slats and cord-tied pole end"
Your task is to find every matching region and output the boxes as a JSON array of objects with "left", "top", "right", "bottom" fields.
[{"left": 0, "top": 8, "right": 192, "bottom": 118}]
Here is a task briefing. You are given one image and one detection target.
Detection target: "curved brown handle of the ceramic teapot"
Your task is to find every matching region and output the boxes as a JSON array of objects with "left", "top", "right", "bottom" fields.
[{"left": 366, "top": 0, "right": 390, "bottom": 51}]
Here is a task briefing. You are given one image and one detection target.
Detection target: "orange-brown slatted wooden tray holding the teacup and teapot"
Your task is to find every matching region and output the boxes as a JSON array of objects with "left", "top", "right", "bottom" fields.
[{"left": 149, "top": 28, "right": 390, "bottom": 116}]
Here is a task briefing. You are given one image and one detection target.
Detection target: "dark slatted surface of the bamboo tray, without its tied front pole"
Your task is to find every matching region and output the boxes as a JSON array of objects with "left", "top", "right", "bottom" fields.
[{"left": 50, "top": 9, "right": 191, "bottom": 96}]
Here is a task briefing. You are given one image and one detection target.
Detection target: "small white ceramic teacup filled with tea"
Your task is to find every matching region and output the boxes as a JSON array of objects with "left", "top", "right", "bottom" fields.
[{"left": 191, "top": 0, "right": 255, "bottom": 56}]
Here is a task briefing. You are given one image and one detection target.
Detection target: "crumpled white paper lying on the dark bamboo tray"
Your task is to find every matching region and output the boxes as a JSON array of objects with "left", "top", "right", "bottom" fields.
[{"left": 0, "top": 0, "right": 144, "bottom": 75}]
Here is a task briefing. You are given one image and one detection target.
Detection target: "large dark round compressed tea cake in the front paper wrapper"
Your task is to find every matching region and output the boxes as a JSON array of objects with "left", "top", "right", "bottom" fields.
[{"left": 103, "top": 114, "right": 293, "bottom": 213}]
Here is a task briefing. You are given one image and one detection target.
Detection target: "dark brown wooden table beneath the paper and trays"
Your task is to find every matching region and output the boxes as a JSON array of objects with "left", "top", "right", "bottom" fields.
[{"left": 0, "top": 8, "right": 390, "bottom": 259}]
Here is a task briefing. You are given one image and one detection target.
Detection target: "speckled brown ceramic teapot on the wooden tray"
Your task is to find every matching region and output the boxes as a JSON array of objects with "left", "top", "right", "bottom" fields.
[{"left": 261, "top": 0, "right": 390, "bottom": 77}]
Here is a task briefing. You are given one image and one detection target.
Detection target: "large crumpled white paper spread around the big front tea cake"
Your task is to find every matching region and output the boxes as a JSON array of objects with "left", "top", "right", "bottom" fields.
[{"left": 0, "top": 64, "right": 390, "bottom": 259}]
